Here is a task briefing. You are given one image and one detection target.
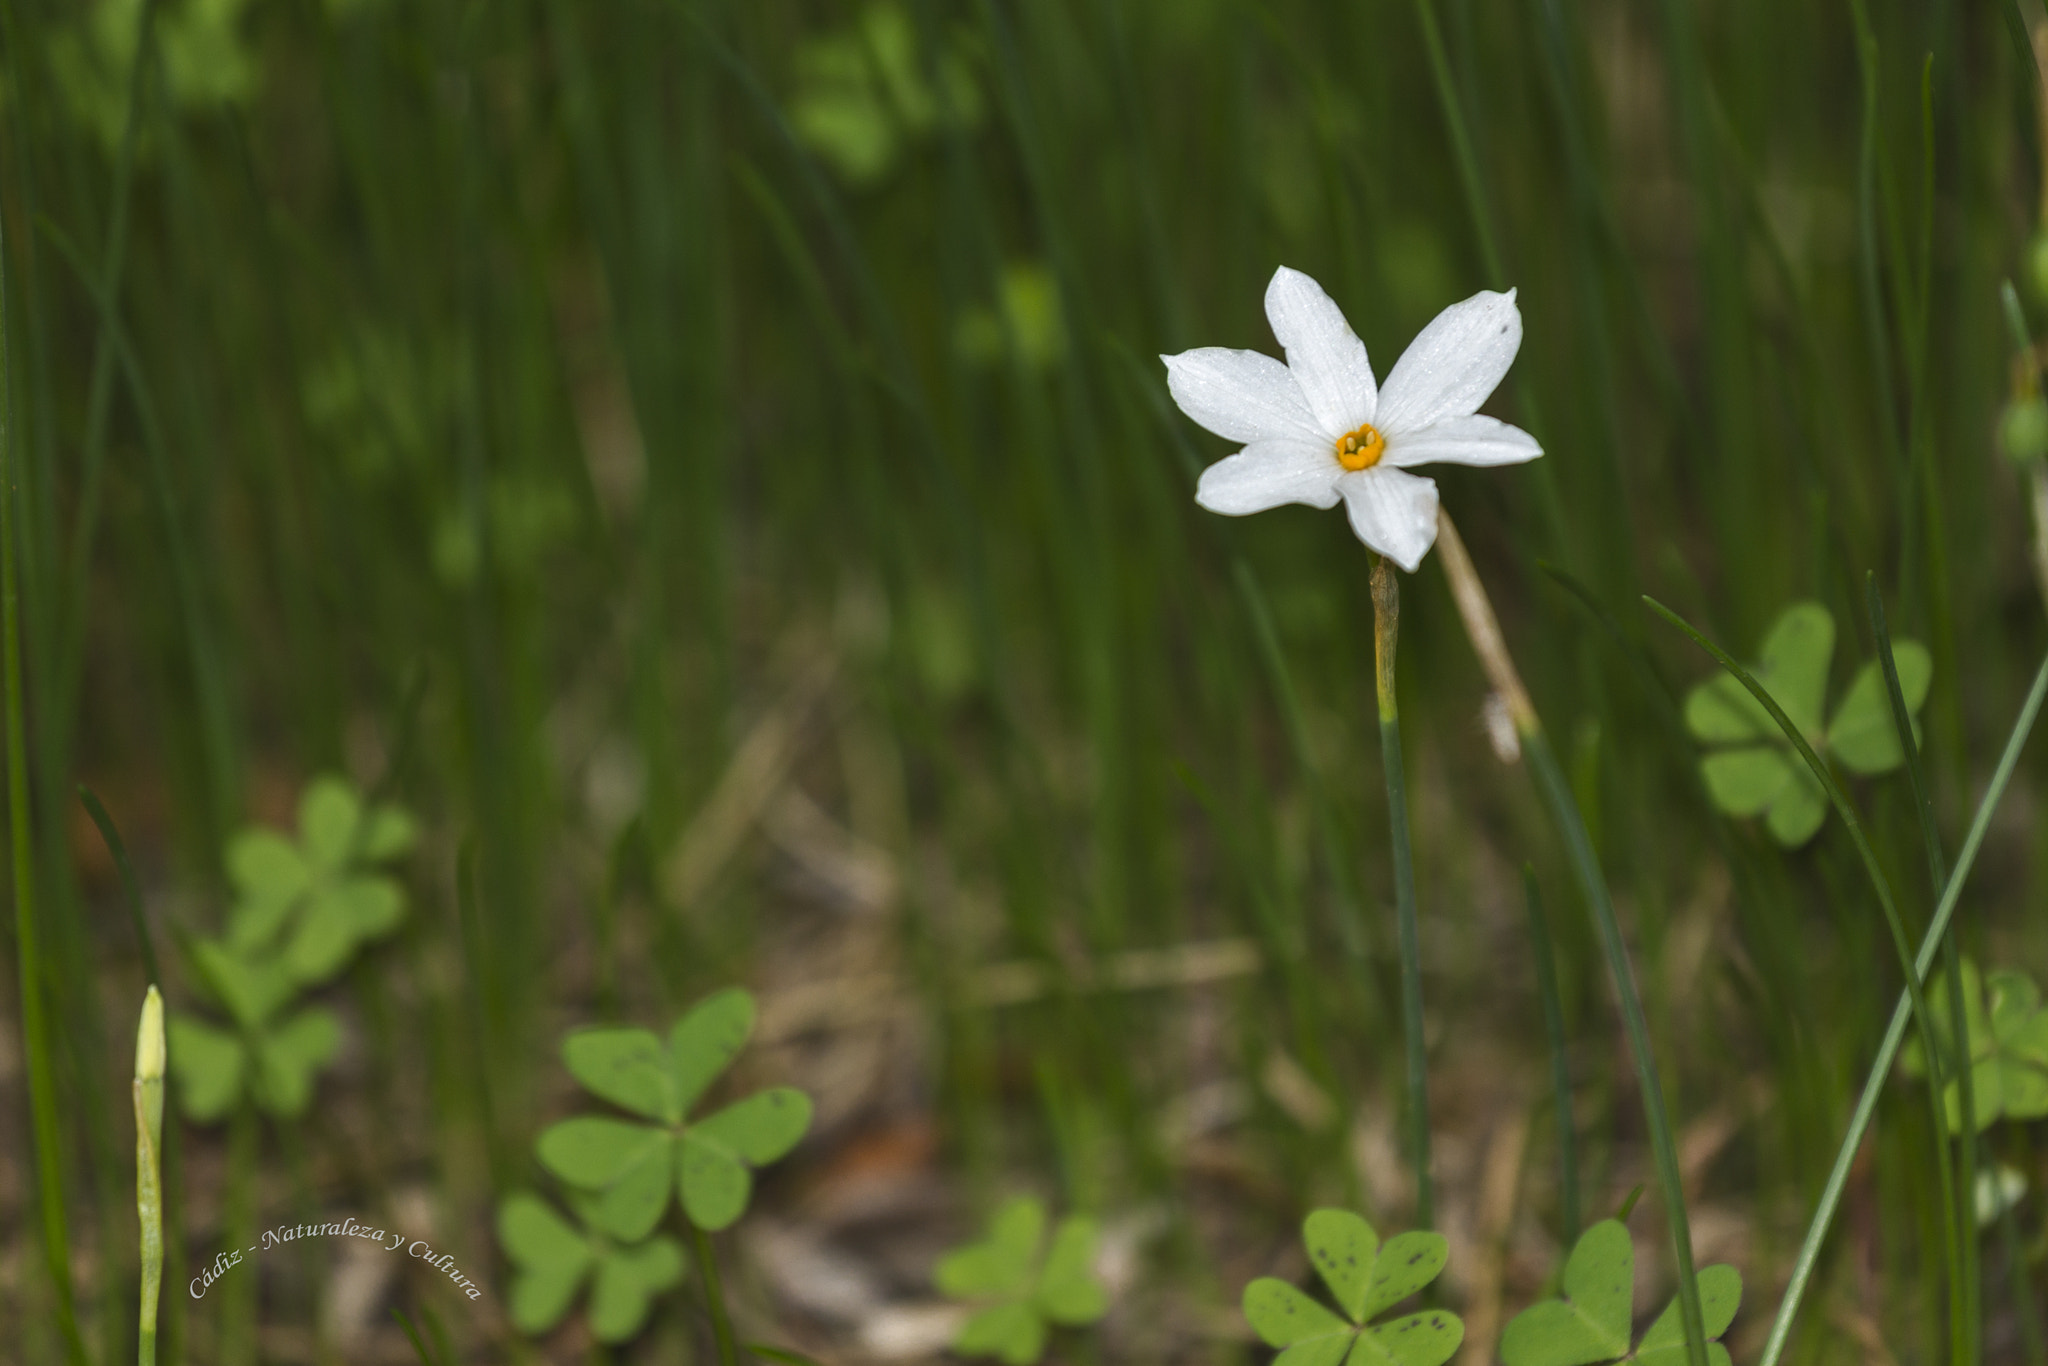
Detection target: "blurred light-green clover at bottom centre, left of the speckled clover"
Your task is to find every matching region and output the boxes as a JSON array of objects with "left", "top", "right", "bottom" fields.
[{"left": 932, "top": 1196, "right": 1110, "bottom": 1366}]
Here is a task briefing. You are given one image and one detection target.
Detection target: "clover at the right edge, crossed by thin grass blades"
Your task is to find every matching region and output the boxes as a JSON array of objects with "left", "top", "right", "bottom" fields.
[{"left": 1898, "top": 958, "right": 2048, "bottom": 1135}]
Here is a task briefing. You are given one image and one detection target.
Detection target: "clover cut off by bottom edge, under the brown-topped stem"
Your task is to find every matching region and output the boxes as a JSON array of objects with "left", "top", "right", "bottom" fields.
[{"left": 1501, "top": 1219, "right": 1743, "bottom": 1366}]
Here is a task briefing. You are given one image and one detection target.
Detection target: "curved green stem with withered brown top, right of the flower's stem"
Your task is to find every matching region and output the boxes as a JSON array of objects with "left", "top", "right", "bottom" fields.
[{"left": 1436, "top": 510, "right": 1708, "bottom": 1366}]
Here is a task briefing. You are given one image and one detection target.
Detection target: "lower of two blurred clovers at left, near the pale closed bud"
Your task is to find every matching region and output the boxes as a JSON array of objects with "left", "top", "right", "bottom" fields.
[{"left": 170, "top": 940, "right": 342, "bottom": 1124}]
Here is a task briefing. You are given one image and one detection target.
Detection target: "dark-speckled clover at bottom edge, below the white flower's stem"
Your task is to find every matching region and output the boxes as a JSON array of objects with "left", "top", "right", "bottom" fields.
[{"left": 1245, "top": 1210, "right": 1464, "bottom": 1366}]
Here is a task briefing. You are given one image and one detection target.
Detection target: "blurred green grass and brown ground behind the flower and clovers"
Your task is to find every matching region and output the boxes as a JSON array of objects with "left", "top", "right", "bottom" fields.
[{"left": 0, "top": 0, "right": 2048, "bottom": 1362}]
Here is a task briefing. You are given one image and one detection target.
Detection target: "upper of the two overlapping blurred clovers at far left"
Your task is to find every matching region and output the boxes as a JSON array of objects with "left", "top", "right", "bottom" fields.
[{"left": 227, "top": 774, "right": 414, "bottom": 985}]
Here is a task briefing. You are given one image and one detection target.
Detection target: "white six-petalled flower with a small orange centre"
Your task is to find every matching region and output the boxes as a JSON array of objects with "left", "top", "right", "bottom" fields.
[{"left": 1159, "top": 266, "right": 1542, "bottom": 573}]
